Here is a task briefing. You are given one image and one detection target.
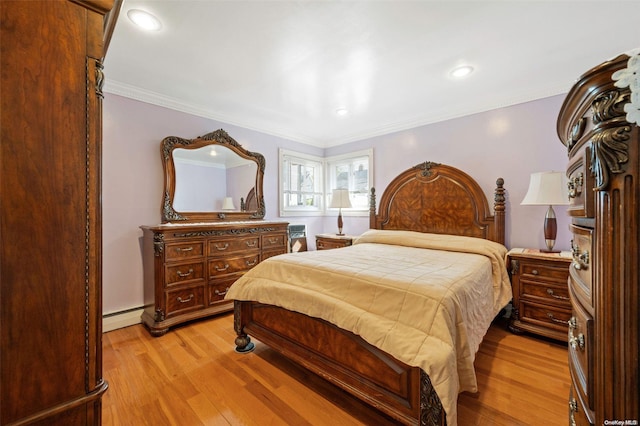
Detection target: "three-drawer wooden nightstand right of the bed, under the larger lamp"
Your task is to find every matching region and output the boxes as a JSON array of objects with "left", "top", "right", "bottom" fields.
[{"left": 507, "top": 249, "right": 572, "bottom": 342}]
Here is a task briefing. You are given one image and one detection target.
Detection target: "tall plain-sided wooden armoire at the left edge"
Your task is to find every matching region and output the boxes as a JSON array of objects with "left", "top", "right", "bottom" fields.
[{"left": 0, "top": 0, "right": 118, "bottom": 425}]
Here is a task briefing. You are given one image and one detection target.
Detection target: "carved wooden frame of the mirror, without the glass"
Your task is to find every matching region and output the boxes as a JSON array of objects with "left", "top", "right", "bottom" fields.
[{"left": 160, "top": 129, "right": 265, "bottom": 223}]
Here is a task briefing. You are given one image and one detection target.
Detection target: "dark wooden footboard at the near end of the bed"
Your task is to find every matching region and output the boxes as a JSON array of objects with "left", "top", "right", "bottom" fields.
[{"left": 234, "top": 300, "right": 446, "bottom": 426}]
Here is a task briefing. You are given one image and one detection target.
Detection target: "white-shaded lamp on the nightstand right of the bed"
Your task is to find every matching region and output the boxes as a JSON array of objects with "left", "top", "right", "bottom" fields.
[{"left": 520, "top": 172, "right": 569, "bottom": 253}]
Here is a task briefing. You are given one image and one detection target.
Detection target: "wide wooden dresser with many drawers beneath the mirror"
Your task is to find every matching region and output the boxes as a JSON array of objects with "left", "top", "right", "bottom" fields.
[{"left": 142, "top": 220, "right": 288, "bottom": 336}]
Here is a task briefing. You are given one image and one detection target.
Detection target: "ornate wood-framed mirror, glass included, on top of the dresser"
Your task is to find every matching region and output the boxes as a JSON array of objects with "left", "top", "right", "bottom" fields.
[{"left": 160, "top": 129, "right": 265, "bottom": 223}]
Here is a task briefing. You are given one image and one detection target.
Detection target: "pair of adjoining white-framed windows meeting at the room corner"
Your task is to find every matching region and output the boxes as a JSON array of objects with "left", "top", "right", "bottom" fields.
[{"left": 279, "top": 149, "right": 373, "bottom": 216}]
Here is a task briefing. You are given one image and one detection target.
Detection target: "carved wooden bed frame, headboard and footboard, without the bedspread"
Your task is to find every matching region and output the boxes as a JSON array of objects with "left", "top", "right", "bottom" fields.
[{"left": 234, "top": 162, "right": 505, "bottom": 425}]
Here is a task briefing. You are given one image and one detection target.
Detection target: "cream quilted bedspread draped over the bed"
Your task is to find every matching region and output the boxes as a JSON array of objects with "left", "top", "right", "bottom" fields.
[{"left": 226, "top": 230, "right": 511, "bottom": 426}]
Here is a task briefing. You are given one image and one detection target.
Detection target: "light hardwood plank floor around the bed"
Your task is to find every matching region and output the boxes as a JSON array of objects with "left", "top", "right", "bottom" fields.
[{"left": 102, "top": 315, "right": 570, "bottom": 426}]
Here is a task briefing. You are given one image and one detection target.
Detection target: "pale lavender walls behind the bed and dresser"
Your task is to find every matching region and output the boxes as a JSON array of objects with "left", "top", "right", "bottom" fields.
[{"left": 102, "top": 93, "right": 570, "bottom": 314}]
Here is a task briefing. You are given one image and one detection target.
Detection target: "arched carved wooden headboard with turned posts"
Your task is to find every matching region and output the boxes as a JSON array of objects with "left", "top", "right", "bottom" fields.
[{"left": 369, "top": 161, "right": 505, "bottom": 244}]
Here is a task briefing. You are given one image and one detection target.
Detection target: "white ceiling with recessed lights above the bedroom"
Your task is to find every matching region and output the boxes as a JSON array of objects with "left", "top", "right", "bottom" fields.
[{"left": 105, "top": 0, "right": 640, "bottom": 147}]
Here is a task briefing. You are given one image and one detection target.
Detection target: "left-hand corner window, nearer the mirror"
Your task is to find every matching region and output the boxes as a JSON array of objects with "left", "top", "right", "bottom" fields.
[{"left": 279, "top": 149, "right": 324, "bottom": 216}]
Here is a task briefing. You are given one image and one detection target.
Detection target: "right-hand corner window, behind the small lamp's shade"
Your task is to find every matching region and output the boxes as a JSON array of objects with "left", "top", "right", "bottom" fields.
[{"left": 326, "top": 149, "right": 373, "bottom": 212}]
